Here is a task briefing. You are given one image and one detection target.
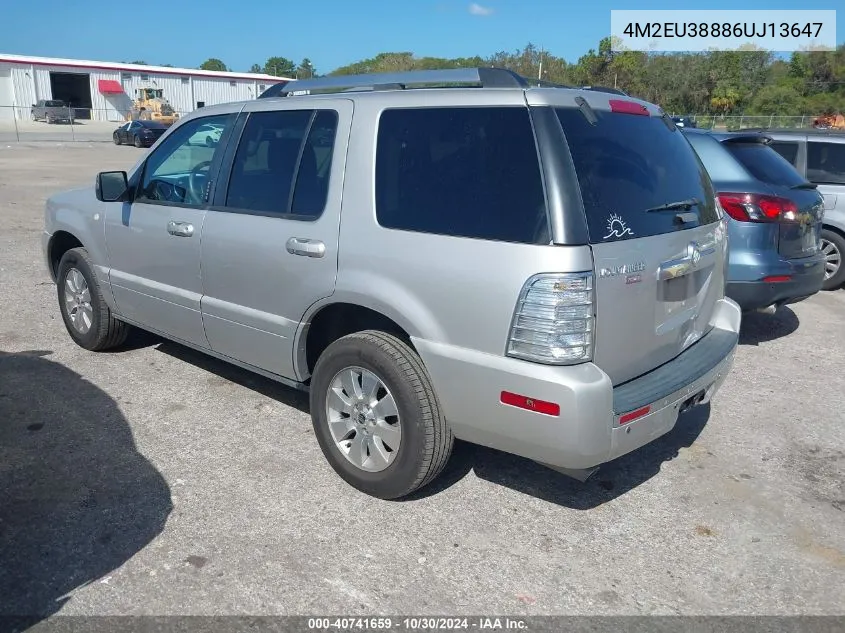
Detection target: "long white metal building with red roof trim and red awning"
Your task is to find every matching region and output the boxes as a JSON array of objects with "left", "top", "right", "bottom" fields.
[{"left": 0, "top": 53, "right": 285, "bottom": 121}]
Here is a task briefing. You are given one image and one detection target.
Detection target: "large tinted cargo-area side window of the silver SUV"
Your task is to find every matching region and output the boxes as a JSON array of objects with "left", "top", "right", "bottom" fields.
[{"left": 376, "top": 107, "right": 551, "bottom": 244}]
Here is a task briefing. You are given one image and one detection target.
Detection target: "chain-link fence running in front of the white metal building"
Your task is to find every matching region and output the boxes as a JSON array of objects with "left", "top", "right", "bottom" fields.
[{"left": 0, "top": 105, "right": 187, "bottom": 143}]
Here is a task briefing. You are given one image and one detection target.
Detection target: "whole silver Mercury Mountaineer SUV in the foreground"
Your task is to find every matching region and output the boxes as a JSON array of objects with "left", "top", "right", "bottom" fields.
[{"left": 43, "top": 68, "right": 741, "bottom": 498}]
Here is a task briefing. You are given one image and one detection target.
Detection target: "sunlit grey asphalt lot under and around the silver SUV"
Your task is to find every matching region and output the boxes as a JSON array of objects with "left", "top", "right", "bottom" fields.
[{"left": 0, "top": 143, "right": 845, "bottom": 615}]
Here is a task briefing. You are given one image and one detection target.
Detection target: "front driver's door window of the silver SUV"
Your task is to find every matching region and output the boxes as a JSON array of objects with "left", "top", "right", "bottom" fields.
[{"left": 137, "top": 114, "right": 235, "bottom": 206}]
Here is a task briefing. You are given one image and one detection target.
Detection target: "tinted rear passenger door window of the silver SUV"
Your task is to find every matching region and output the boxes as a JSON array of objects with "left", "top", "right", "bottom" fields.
[{"left": 226, "top": 110, "right": 338, "bottom": 219}]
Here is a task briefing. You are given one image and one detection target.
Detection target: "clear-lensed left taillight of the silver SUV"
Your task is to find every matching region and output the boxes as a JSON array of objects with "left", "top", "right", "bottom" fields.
[{"left": 507, "top": 272, "right": 595, "bottom": 365}]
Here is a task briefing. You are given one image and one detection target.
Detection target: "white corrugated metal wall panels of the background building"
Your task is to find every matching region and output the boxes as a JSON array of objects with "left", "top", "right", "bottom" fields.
[{"left": 0, "top": 63, "right": 265, "bottom": 121}]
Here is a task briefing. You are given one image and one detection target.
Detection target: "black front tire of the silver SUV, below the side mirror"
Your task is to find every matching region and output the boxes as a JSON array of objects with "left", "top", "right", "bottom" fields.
[{"left": 56, "top": 248, "right": 130, "bottom": 352}]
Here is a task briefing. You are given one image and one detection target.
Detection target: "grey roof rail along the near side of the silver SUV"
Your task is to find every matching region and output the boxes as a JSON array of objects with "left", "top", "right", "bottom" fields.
[{"left": 278, "top": 68, "right": 530, "bottom": 96}]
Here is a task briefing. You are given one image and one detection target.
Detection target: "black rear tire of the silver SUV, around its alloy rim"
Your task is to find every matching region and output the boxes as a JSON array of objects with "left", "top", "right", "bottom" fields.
[{"left": 310, "top": 330, "right": 454, "bottom": 499}]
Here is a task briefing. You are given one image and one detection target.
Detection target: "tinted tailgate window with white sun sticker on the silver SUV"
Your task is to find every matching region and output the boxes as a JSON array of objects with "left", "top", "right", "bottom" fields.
[{"left": 557, "top": 108, "right": 719, "bottom": 243}]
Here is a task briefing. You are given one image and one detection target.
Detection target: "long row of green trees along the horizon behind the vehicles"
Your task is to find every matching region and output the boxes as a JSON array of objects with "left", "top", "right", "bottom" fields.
[{"left": 322, "top": 38, "right": 845, "bottom": 116}]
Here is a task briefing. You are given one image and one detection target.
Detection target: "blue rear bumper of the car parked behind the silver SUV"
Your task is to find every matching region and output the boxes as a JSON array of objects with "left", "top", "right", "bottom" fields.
[{"left": 725, "top": 256, "right": 824, "bottom": 311}]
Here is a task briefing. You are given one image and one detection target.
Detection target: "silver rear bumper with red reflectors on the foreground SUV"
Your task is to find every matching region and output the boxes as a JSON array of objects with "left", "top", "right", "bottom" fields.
[{"left": 414, "top": 299, "right": 741, "bottom": 469}]
